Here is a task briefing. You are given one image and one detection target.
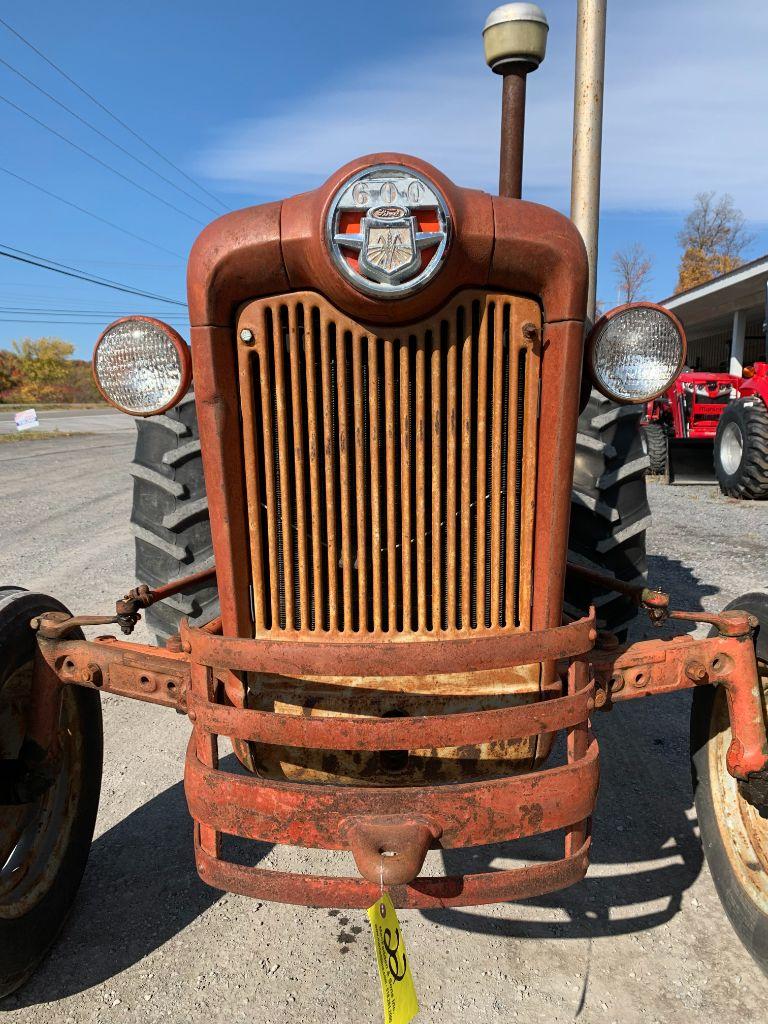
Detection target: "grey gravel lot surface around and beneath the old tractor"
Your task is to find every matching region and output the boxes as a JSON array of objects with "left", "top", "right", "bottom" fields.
[{"left": 0, "top": 433, "right": 768, "bottom": 1024}]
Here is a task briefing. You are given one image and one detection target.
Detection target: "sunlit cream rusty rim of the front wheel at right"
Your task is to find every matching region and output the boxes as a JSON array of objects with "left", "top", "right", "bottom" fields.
[{"left": 708, "top": 679, "right": 768, "bottom": 914}]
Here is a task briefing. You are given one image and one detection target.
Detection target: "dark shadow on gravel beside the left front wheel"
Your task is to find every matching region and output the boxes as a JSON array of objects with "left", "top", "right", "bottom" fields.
[{"left": 0, "top": 756, "right": 271, "bottom": 1015}]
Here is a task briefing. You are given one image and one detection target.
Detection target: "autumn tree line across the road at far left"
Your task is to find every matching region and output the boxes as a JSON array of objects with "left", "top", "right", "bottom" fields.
[{"left": 0, "top": 338, "right": 102, "bottom": 403}]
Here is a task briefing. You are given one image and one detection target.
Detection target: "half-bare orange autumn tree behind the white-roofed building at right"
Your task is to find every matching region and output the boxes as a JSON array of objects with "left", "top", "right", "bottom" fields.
[{"left": 675, "top": 191, "right": 754, "bottom": 293}]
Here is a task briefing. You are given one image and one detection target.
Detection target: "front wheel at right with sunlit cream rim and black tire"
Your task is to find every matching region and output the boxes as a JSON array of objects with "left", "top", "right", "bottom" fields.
[{"left": 690, "top": 594, "right": 768, "bottom": 975}]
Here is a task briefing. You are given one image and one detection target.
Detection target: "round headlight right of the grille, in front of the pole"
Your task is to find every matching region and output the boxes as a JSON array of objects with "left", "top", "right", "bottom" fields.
[{"left": 587, "top": 302, "right": 685, "bottom": 402}]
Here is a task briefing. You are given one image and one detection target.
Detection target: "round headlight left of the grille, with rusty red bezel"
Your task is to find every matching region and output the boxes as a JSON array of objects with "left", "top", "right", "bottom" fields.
[{"left": 93, "top": 316, "right": 191, "bottom": 416}]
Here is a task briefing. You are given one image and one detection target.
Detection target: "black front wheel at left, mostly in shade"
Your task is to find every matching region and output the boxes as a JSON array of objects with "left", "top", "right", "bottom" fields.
[{"left": 0, "top": 587, "right": 102, "bottom": 997}]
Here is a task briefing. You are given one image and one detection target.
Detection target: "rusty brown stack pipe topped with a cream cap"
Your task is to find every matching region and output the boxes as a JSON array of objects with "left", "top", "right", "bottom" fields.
[{"left": 482, "top": 3, "right": 549, "bottom": 199}]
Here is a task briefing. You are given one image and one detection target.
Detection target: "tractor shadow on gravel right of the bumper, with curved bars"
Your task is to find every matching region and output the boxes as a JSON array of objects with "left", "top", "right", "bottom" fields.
[{"left": 423, "top": 556, "right": 717, "bottom": 939}]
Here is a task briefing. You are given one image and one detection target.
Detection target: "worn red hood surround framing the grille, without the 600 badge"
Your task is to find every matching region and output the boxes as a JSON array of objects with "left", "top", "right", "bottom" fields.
[{"left": 188, "top": 154, "right": 587, "bottom": 684}]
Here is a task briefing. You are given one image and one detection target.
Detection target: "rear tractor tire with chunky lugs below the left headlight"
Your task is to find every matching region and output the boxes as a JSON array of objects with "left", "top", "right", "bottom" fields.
[{"left": 131, "top": 389, "right": 218, "bottom": 644}]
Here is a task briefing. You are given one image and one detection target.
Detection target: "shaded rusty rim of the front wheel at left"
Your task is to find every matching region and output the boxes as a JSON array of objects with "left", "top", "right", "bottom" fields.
[{"left": 0, "top": 663, "right": 82, "bottom": 919}]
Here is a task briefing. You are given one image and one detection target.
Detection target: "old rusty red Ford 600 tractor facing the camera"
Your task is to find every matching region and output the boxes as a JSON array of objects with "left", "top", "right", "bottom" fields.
[{"left": 0, "top": 3, "right": 768, "bottom": 1007}]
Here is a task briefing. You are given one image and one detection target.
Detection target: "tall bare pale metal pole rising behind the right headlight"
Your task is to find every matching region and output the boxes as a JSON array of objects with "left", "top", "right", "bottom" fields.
[{"left": 570, "top": 0, "right": 608, "bottom": 322}]
